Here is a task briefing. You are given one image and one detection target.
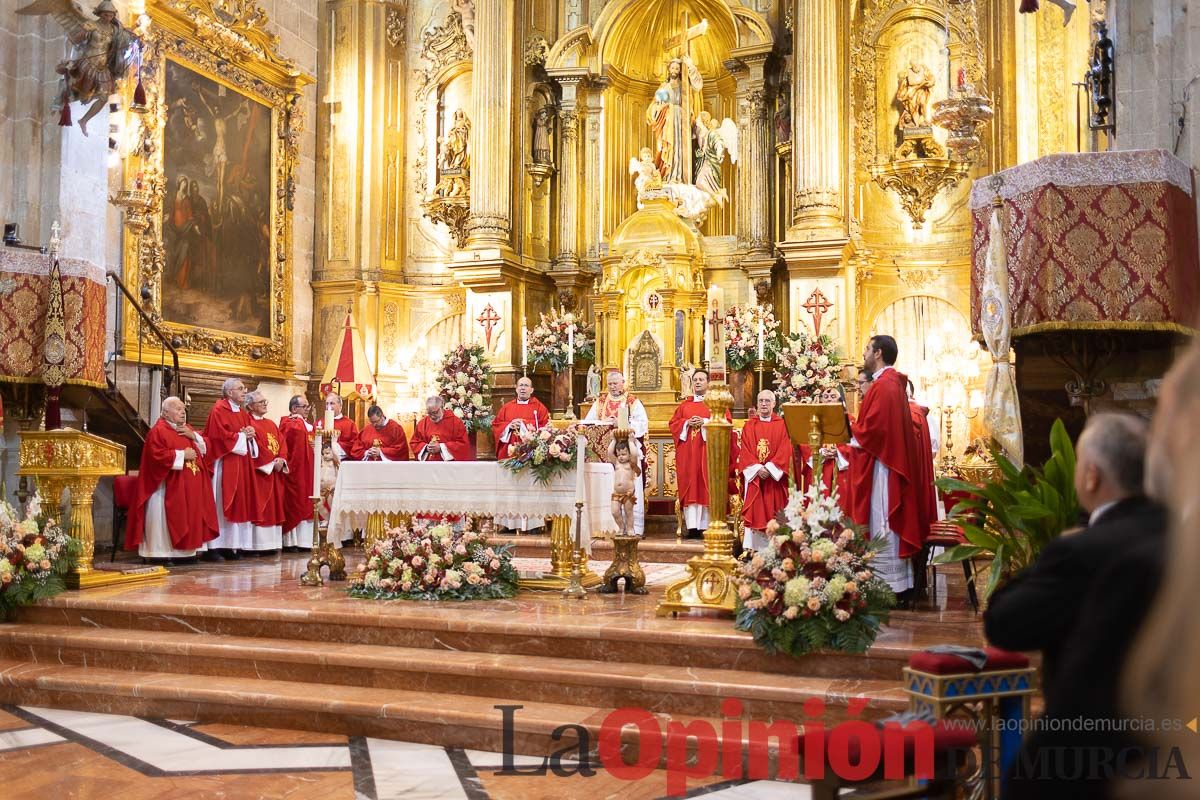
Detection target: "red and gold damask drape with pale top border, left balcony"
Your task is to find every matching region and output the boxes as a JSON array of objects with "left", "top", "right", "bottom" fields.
[{"left": 0, "top": 247, "right": 107, "bottom": 387}]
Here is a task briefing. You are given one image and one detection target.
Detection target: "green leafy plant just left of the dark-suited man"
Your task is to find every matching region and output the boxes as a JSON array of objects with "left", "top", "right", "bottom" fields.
[{"left": 935, "top": 420, "right": 1080, "bottom": 597}]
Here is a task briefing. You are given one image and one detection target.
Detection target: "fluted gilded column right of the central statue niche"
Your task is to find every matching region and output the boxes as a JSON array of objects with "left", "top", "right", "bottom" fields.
[{"left": 788, "top": 0, "right": 845, "bottom": 239}]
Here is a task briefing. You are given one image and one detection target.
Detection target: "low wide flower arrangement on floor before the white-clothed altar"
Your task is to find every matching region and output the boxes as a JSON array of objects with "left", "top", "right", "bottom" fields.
[{"left": 349, "top": 524, "right": 517, "bottom": 600}]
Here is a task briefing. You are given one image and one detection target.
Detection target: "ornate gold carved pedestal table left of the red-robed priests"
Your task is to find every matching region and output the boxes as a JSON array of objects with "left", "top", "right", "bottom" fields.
[{"left": 18, "top": 428, "right": 167, "bottom": 589}]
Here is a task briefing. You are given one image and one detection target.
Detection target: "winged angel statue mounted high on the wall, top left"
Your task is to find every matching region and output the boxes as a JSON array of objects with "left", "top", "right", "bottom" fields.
[{"left": 17, "top": 0, "right": 139, "bottom": 136}]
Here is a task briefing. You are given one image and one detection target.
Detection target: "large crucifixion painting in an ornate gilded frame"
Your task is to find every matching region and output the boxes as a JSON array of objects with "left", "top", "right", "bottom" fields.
[{"left": 124, "top": 0, "right": 313, "bottom": 377}]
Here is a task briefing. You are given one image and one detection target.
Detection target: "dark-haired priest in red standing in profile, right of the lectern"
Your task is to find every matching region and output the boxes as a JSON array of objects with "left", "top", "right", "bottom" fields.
[{"left": 851, "top": 335, "right": 929, "bottom": 604}]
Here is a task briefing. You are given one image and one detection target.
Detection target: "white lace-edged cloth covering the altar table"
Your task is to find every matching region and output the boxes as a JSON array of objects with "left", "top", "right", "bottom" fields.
[{"left": 329, "top": 461, "right": 617, "bottom": 552}]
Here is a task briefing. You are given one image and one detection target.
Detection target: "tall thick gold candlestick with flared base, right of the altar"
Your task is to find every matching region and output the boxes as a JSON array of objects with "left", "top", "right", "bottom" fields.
[{"left": 655, "top": 383, "right": 738, "bottom": 616}]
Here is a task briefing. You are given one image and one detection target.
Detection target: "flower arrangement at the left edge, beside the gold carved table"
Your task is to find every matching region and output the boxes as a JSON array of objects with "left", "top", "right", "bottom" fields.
[{"left": 0, "top": 501, "right": 82, "bottom": 620}]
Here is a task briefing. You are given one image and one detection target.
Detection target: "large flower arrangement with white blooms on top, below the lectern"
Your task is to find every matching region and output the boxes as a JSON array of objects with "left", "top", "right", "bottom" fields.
[{"left": 734, "top": 486, "right": 895, "bottom": 656}]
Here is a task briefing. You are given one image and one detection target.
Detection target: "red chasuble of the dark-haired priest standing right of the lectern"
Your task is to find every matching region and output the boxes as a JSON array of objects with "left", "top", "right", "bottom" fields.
[{"left": 851, "top": 368, "right": 929, "bottom": 558}]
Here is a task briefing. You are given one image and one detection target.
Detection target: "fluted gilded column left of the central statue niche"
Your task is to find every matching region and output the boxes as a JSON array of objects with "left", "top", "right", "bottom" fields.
[{"left": 467, "top": 0, "right": 516, "bottom": 249}]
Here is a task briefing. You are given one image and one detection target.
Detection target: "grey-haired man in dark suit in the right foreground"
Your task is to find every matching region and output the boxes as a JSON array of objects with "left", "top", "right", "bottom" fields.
[{"left": 984, "top": 414, "right": 1168, "bottom": 800}]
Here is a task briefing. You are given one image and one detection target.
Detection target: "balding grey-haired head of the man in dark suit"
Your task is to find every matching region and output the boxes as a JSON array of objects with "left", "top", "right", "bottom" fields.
[{"left": 1075, "top": 414, "right": 1148, "bottom": 511}]
